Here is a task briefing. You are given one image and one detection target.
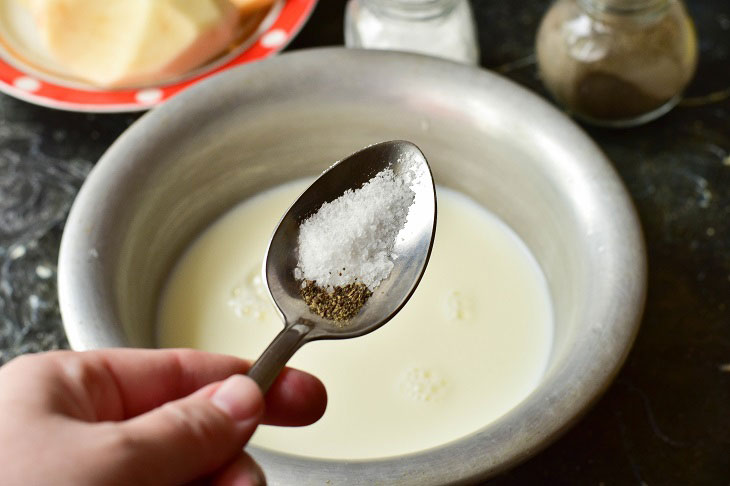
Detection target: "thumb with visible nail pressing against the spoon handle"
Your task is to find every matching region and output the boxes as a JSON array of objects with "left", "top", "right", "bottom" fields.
[{"left": 120, "top": 375, "right": 264, "bottom": 484}]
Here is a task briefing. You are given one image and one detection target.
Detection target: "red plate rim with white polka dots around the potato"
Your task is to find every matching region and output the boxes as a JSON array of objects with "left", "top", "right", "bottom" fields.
[{"left": 0, "top": 0, "right": 317, "bottom": 113}]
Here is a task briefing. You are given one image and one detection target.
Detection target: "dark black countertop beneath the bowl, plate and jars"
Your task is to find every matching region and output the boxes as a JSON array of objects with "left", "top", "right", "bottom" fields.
[{"left": 0, "top": 0, "right": 730, "bottom": 486}]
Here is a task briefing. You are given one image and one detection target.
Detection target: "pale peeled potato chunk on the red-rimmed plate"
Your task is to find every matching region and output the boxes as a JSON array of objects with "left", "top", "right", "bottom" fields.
[{"left": 22, "top": 0, "right": 238, "bottom": 86}]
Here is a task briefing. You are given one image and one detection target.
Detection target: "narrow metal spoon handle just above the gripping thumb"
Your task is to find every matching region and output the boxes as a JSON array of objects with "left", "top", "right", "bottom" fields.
[{"left": 247, "top": 322, "right": 312, "bottom": 393}]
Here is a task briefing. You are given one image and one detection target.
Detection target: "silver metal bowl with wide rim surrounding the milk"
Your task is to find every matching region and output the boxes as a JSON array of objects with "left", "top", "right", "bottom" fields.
[{"left": 59, "top": 48, "right": 646, "bottom": 486}]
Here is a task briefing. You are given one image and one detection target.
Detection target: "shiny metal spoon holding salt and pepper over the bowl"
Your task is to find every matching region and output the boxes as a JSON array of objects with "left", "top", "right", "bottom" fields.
[{"left": 248, "top": 141, "right": 436, "bottom": 393}]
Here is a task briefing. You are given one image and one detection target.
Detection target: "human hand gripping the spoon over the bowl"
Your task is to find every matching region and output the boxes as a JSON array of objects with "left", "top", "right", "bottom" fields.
[{"left": 0, "top": 349, "right": 327, "bottom": 486}]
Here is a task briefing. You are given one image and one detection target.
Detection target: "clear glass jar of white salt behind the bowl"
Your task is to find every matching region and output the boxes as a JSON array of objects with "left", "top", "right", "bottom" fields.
[{"left": 345, "top": 0, "right": 479, "bottom": 64}]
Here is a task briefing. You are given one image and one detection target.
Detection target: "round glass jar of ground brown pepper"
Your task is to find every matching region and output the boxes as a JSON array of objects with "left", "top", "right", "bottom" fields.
[{"left": 537, "top": 0, "right": 697, "bottom": 127}]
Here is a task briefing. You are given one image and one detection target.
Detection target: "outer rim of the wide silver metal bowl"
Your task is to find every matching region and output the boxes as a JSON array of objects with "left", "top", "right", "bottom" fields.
[{"left": 58, "top": 47, "right": 647, "bottom": 484}]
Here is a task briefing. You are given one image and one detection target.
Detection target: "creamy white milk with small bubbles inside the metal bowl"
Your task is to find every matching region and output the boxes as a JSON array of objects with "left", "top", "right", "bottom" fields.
[{"left": 159, "top": 182, "right": 553, "bottom": 459}]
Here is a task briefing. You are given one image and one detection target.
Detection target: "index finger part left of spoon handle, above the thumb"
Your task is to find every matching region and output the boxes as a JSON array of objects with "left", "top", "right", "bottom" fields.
[{"left": 1, "top": 349, "right": 249, "bottom": 422}]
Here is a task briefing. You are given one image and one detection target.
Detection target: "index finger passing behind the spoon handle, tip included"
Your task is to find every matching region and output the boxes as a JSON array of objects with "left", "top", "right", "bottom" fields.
[{"left": 7, "top": 349, "right": 327, "bottom": 425}]
